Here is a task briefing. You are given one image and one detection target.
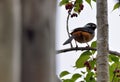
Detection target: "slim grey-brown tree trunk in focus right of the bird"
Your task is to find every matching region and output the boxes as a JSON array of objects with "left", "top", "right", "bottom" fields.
[{"left": 97, "top": 0, "right": 109, "bottom": 82}]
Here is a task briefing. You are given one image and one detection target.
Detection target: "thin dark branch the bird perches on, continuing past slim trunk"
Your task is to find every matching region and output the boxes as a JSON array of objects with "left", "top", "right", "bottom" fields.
[{"left": 57, "top": 47, "right": 120, "bottom": 57}]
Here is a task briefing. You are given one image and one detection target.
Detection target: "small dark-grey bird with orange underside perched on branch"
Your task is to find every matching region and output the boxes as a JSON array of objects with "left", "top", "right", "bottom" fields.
[{"left": 63, "top": 23, "right": 97, "bottom": 47}]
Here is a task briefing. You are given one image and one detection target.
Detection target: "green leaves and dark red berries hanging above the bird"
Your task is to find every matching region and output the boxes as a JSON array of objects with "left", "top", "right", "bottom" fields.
[{"left": 59, "top": 0, "right": 96, "bottom": 17}]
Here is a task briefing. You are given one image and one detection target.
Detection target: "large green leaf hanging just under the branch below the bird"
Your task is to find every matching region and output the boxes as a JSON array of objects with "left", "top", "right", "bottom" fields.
[{"left": 75, "top": 51, "right": 92, "bottom": 68}]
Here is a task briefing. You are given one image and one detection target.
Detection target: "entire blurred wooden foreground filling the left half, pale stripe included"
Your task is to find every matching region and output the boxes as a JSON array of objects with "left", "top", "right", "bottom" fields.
[{"left": 0, "top": 0, "right": 57, "bottom": 82}]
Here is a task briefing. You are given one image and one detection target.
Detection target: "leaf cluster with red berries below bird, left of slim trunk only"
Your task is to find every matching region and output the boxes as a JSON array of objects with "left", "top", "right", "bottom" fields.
[{"left": 60, "top": 41, "right": 96, "bottom": 82}]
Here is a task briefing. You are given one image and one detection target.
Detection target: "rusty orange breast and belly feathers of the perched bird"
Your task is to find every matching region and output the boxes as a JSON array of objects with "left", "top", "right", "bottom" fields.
[{"left": 71, "top": 31, "right": 94, "bottom": 43}]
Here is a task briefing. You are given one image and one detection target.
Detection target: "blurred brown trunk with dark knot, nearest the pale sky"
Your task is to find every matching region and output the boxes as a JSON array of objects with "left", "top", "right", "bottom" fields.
[{"left": 21, "top": 0, "right": 56, "bottom": 82}]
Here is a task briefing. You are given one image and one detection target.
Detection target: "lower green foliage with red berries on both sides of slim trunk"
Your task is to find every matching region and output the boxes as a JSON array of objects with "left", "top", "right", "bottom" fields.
[{"left": 60, "top": 41, "right": 120, "bottom": 82}]
